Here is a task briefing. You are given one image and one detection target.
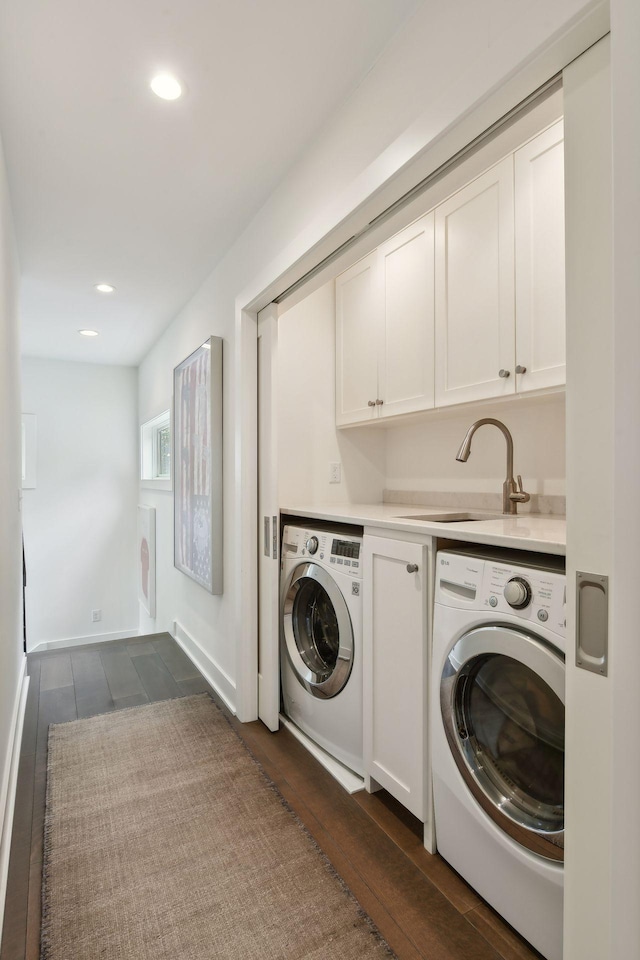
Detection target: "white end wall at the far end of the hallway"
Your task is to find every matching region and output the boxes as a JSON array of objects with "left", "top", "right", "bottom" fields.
[{"left": 22, "top": 358, "right": 139, "bottom": 650}]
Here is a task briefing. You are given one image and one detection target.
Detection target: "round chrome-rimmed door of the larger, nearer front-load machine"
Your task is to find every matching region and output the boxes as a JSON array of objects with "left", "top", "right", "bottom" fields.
[{"left": 440, "top": 626, "right": 565, "bottom": 861}]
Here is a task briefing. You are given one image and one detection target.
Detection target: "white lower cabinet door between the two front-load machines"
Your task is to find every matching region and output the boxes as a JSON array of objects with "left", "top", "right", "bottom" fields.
[{"left": 363, "top": 536, "right": 427, "bottom": 821}]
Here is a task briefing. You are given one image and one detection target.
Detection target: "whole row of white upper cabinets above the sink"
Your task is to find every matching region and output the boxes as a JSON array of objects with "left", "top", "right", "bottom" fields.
[{"left": 336, "top": 120, "right": 566, "bottom": 425}]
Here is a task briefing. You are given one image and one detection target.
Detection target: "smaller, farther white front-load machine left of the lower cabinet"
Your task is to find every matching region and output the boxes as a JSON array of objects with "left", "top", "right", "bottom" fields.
[{"left": 280, "top": 526, "right": 364, "bottom": 776}]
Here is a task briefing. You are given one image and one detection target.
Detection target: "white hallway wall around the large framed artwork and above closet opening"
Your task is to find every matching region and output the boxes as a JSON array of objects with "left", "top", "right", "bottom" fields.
[{"left": 139, "top": 0, "right": 607, "bottom": 719}]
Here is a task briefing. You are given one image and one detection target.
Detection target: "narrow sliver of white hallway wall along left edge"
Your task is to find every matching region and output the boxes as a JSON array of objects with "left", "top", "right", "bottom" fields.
[{"left": 0, "top": 131, "right": 24, "bottom": 933}]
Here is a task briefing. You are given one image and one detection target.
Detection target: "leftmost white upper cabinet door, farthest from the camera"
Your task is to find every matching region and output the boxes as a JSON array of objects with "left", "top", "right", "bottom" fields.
[{"left": 336, "top": 250, "right": 382, "bottom": 425}]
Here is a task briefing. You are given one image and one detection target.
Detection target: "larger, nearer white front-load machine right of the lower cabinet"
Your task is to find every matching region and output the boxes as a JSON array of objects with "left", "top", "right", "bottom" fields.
[{"left": 431, "top": 548, "right": 566, "bottom": 960}]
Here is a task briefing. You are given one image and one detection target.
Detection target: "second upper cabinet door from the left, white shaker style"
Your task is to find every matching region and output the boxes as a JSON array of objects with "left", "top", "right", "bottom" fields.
[{"left": 379, "top": 213, "right": 434, "bottom": 417}]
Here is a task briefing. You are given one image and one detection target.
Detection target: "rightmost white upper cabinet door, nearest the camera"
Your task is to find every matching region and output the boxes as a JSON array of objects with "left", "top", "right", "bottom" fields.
[{"left": 515, "top": 120, "right": 566, "bottom": 391}]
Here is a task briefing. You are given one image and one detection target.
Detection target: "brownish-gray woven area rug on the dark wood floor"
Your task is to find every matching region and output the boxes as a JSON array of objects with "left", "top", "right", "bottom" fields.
[{"left": 41, "top": 694, "right": 392, "bottom": 960}]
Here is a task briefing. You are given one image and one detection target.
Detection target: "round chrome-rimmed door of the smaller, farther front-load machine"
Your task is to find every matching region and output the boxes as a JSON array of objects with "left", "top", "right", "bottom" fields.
[{"left": 282, "top": 562, "right": 354, "bottom": 700}]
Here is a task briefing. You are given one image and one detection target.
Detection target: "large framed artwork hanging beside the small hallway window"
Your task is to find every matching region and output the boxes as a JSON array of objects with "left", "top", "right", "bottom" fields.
[{"left": 173, "top": 337, "right": 222, "bottom": 594}]
